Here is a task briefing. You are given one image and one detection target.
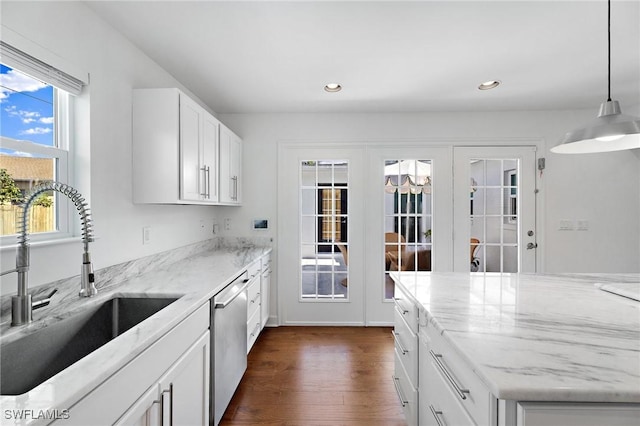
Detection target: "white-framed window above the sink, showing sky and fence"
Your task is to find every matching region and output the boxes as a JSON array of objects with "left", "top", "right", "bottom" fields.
[{"left": 0, "top": 42, "right": 82, "bottom": 245}]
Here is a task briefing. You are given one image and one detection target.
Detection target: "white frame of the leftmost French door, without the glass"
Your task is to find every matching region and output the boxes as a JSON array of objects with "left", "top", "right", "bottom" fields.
[{"left": 278, "top": 143, "right": 365, "bottom": 326}]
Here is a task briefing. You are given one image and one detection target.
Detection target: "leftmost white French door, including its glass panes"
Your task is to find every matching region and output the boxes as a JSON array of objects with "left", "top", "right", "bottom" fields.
[{"left": 278, "top": 146, "right": 366, "bottom": 325}]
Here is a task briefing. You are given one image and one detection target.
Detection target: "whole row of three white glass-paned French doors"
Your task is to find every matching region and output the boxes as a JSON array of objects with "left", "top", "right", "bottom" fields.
[{"left": 278, "top": 144, "right": 537, "bottom": 325}]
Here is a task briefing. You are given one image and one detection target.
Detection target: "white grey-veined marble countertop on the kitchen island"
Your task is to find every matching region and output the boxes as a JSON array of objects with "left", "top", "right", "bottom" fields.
[{"left": 392, "top": 272, "right": 640, "bottom": 403}]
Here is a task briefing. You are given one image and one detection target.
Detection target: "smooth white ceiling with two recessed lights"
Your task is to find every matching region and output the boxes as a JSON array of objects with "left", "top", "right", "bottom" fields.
[{"left": 87, "top": 0, "right": 640, "bottom": 114}]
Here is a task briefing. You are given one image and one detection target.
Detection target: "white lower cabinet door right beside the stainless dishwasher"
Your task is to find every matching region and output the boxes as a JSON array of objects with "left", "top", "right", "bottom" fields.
[{"left": 159, "top": 331, "right": 209, "bottom": 426}]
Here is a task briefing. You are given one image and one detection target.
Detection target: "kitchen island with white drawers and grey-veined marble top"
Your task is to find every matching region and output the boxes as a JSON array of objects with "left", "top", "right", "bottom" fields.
[{"left": 392, "top": 272, "right": 640, "bottom": 425}]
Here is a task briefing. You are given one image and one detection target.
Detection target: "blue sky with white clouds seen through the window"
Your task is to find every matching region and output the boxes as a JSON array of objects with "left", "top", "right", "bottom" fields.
[{"left": 0, "top": 64, "right": 54, "bottom": 151}]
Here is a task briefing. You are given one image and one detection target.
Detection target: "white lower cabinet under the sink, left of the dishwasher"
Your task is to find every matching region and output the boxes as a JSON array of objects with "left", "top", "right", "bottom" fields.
[{"left": 54, "top": 303, "right": 210, "bottom": 426}]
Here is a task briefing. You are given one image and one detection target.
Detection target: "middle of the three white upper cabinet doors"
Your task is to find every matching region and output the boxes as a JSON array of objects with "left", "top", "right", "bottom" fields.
[{"left": 200, "top": 114, "right": 220, "bottom": 202}]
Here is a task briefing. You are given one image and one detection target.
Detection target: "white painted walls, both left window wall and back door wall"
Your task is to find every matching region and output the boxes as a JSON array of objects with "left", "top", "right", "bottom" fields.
[{"left": 1, "top": 2, "right": 640, "bottom": 300}]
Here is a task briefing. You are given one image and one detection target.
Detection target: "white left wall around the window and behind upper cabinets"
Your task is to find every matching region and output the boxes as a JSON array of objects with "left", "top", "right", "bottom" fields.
[{"left": 1, "top": 2, "right": 216, "bottom": 293}]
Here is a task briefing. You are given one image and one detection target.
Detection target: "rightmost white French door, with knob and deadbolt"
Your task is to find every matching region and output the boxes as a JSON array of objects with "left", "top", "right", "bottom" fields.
[{"left": 453, "top": 147, "right": 537, "bottom": 272}]
